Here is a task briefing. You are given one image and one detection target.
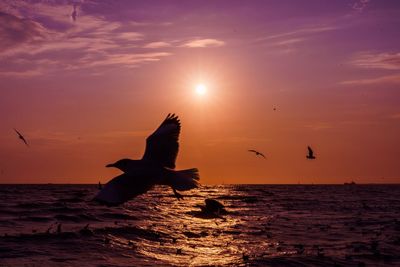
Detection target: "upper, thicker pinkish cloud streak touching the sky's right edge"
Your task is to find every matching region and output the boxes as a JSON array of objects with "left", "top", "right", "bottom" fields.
[{"left": 350, "top": 52, "right": 400, "bottom": 70}]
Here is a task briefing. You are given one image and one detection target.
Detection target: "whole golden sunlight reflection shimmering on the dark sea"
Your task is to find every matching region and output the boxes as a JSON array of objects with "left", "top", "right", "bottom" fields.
[{"left": 108, "top": 187, "right": 287, "bottom": 266}]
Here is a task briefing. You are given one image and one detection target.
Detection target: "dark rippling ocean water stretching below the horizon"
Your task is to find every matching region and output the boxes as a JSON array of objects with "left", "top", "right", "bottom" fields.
[{"left": 0, "top": 185, "right": 400, "bottom": 267}]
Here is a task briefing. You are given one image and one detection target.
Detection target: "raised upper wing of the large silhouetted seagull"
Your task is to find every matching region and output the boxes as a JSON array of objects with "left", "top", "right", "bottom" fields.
[{"left": 142, "top": 114, "right": 181, "bottom": 168}]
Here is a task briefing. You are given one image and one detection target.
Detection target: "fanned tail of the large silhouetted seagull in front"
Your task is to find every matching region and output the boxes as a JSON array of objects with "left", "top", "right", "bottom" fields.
[{"left": 166, "top": 168, "right": 200, "bottom": 191}]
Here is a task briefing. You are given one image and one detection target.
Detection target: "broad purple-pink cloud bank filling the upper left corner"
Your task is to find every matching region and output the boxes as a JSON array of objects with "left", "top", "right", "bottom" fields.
[{"left": 0, "top": 1, "right": 171, "bottom": 77}]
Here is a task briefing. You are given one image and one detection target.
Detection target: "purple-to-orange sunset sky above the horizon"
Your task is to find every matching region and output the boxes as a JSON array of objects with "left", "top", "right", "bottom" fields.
[{"left": 0, "top": 0, "right": 400, "bottom": 184}]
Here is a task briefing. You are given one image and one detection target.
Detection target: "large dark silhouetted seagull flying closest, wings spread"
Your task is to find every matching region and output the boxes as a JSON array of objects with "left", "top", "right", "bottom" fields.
[{"left": 94, "top": 114, "right": 199, "bottom": 205}]
